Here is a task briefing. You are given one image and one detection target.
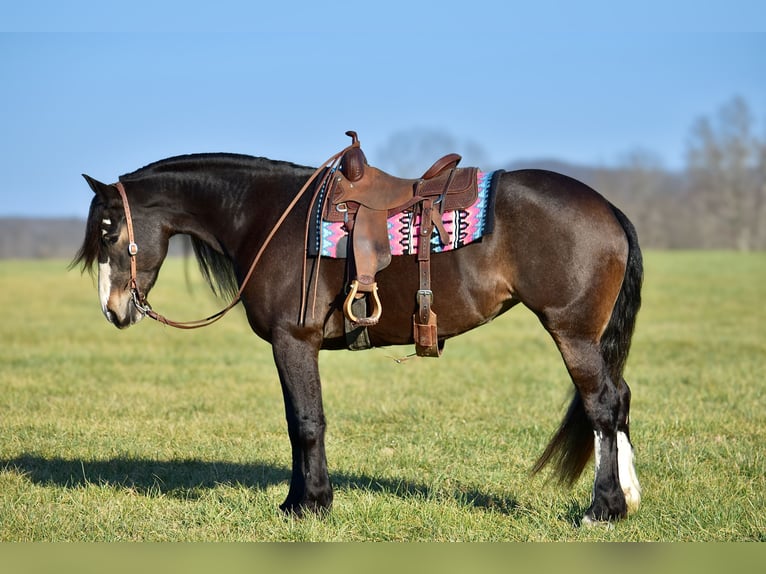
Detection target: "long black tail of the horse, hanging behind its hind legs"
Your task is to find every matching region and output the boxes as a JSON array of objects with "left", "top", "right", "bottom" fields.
[{"left": 532, "top": 205, "right": 644, "bottom": 485}]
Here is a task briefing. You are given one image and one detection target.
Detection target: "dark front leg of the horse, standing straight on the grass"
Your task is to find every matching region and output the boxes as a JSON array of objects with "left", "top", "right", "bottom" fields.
[{"left": 272, "top": 331, "right": 332, "bottom": 515}]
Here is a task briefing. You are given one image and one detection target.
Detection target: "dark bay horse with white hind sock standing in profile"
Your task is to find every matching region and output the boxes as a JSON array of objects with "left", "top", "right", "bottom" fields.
[{"left": 73, "top": 144, "right": 643, "bottom": 524}]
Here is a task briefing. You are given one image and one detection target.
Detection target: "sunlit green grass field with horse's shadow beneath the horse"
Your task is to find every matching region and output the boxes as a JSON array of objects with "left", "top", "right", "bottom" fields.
[{"left": 0, "top": 252, "right": 766, "bottom": 541}]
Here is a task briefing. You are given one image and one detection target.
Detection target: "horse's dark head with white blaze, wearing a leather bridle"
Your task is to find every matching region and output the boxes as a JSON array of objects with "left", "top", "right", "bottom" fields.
[{"left": 73, "top": 175, "right": 168, "bottom": 329}]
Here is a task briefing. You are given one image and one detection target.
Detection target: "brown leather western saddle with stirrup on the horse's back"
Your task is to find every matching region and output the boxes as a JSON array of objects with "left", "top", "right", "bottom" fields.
[{"left": 323, "top": 131, "right": 478, "bottom": 357}]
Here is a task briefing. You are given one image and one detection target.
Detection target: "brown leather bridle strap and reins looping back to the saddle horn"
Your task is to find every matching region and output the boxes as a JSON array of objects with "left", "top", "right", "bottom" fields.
[{"left": 114, "top": 143, "right": 358, "bottom": 329}]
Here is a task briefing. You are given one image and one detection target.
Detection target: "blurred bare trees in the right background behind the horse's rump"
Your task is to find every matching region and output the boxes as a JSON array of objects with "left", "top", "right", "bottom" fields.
[{"left": 592, "top": 98, "right": 766, "bottom": 251}]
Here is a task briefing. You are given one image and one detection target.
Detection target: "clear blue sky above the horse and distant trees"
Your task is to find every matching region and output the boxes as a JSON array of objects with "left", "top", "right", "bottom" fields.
[{"left": 0, "top": 0, "right": 766, "bottom": 216}]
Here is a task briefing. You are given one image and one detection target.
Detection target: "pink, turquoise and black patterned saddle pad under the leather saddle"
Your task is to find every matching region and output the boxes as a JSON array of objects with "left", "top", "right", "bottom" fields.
[{"left": 308, "top": 171, "right": 500, "bottom": 259}]
